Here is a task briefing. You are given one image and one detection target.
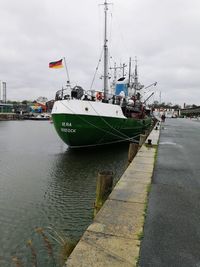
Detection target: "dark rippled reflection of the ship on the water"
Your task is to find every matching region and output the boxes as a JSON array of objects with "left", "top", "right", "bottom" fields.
[{"left": 44, "top": 142, "right": 127, "bottom": 238}]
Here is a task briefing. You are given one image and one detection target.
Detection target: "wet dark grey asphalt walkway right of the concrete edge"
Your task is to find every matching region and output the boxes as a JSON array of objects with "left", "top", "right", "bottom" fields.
[{"left": 139, "top": 119, "right": 200, "bottom": 267}]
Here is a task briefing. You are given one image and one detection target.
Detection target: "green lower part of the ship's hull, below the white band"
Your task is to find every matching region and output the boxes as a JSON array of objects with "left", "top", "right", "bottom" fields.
[{"left": 52, "top": 114, "right": 152, "bottom": 147}]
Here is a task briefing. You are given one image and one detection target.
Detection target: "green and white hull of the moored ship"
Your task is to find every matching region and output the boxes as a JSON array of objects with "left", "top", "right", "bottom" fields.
[{"left": 52, "top": 100, "right": 152, "bottom": 147}]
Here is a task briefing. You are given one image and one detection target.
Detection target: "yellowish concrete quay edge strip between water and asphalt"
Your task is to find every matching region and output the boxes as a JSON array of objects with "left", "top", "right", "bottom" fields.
[{"left": 65, "top": 126, "right": 160, "bottom": 267}]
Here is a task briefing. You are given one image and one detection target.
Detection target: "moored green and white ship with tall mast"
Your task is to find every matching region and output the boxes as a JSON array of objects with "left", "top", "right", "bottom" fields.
[{"left": 52, "top": 0, "right": 155, "bottom": 147}]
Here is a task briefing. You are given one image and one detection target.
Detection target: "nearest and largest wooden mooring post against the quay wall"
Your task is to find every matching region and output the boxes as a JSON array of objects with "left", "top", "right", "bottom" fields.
[{"left": 94, "top": 171, "right": 113, "bottom": 216}]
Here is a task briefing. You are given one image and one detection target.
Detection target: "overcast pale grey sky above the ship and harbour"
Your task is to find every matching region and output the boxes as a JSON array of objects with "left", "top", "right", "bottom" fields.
[{"left": 0, "top": 0, "right": 200, "bottom": 105}]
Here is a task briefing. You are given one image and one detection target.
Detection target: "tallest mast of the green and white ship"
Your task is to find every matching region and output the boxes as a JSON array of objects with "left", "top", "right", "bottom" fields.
[{"left": 104, "top": 0, "right": 108, "bottom": 100}]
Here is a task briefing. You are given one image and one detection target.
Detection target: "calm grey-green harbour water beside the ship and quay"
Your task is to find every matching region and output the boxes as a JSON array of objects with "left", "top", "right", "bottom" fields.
[{"left": 0, "top": 121, "right": 128, "bottom": 267}]
